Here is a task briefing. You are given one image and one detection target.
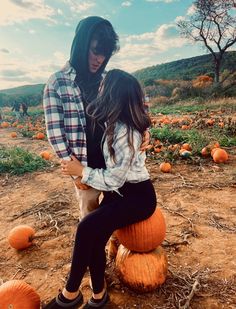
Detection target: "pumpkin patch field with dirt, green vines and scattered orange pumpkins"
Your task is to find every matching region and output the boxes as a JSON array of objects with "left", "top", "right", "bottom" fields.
[{"left": 0, "top": 102, "right": 236, "bottom": 309}]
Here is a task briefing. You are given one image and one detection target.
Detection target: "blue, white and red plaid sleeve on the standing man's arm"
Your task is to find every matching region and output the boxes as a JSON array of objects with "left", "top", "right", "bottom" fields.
[{"left": 43, "top": 82, "right": 71, "bottom": 159}]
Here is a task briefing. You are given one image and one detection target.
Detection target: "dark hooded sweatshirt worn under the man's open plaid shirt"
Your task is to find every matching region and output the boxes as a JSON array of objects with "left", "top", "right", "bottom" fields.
[{"left": 70, "top": 16, "right": 111, "bottom": 168}]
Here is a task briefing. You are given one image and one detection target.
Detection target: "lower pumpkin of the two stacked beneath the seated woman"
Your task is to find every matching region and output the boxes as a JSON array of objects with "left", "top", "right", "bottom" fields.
[{"left": 116, "top": 245, "right": 168, "bottom": 292}]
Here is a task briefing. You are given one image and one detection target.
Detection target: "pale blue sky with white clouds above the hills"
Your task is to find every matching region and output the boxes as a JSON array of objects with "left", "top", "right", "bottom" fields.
[{"left": 0, "top": 0, "right": 214, "bottom": 89}]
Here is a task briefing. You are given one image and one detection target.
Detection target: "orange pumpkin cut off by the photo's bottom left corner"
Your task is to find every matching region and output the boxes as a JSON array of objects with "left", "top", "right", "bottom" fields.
[{"left": 0, "top": 280, "right": 40, "bottom": 309}]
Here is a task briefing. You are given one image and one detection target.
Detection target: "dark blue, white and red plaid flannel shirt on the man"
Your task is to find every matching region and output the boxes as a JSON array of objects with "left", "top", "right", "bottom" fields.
[{"left": 43, "top": 62, "right": 87, "bottom": 165}]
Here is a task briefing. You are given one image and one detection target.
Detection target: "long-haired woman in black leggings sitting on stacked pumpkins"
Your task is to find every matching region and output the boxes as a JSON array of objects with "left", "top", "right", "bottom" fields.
[{"left": 46, "top": 70, "right": 156, "bottom": 309}]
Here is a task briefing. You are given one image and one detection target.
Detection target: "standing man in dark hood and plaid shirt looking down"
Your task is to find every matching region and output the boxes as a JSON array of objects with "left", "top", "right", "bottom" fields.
[{"left": 43, "top": 16, "right": 119, "bottom": 218}]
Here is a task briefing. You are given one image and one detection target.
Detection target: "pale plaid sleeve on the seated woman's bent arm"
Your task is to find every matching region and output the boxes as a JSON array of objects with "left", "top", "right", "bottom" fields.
[{"left": 81, "top": 129, "right": 141, "bottom": 191}]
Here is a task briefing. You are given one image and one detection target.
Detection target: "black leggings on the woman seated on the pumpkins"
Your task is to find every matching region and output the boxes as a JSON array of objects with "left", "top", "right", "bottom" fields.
[{"left": 66, "top": 180, "right": 156, "bottom": 293}]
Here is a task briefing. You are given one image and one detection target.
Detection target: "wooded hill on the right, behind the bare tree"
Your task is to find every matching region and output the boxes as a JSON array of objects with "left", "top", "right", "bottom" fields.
[{"left": 133, "top": 51, "right": 236, "bottom": 82}]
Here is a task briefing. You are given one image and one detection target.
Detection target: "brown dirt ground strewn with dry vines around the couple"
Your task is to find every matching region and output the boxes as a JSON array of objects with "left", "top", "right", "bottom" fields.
[{"left": 0, "top": 128, "right": 236, "bottom": 309}]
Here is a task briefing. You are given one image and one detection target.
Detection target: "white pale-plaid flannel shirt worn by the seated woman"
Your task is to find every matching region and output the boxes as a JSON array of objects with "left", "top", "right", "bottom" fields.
[{"left": 81, "top": 122, "right": 150, "bottom": 193}]
